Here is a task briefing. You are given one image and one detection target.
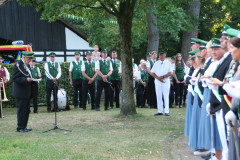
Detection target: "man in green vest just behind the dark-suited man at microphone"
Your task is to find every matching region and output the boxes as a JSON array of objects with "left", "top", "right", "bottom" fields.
[{"left": 29, "top": 57, "right": 41, "bottom": 113}]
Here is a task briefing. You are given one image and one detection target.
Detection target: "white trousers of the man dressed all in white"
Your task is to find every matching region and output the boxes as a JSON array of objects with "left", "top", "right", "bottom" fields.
[{"left": 155, "top": 80, "right": 170, "bottom": 113}]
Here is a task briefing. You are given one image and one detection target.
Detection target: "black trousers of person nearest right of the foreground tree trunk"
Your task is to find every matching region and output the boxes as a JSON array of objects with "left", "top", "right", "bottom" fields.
[{"left": 137, "top": 84, "right": 147, "bottom": 107}]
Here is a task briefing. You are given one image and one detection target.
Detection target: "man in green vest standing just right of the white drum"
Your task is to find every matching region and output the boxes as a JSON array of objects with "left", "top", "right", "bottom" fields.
[{"left": 69, "top": 51, "right": 83, "bottom": 109}]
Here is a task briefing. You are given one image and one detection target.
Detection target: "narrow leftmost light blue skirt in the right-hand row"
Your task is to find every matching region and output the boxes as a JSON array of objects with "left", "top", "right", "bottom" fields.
[{"left": 184, "top": 92, "right": 192, "bottom": 137}]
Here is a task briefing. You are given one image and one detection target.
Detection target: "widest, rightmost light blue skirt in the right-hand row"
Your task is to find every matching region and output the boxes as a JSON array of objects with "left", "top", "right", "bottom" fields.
[{"left": 198, "top": 87, "right": 222, "bottom": 150}]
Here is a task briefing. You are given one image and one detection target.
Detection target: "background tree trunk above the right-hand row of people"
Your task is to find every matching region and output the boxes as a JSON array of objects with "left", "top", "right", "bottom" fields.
[{"left": 181, "top": 0, "right": 201, "bottom": 61}]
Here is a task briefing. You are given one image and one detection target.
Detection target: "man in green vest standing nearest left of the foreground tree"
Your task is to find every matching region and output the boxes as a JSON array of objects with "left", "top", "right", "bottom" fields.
[{"left": 109, "top": 51, "right": 122, "bottom": 108}]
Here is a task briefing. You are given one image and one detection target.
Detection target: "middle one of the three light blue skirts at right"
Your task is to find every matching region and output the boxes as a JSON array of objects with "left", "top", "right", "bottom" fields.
[{"left": 188, "top": 93, "right": 202, "bottom": 150}]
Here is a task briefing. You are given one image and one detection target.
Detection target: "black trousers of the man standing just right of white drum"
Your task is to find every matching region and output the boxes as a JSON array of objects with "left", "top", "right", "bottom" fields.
[{"left": 73, "top": 79, "right": 83, "bottom": 107}]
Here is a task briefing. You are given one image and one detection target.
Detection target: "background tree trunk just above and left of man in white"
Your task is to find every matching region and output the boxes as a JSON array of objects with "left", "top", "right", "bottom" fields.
[{"left": 147, "top": 4, "right": 159, "bottom": 52}]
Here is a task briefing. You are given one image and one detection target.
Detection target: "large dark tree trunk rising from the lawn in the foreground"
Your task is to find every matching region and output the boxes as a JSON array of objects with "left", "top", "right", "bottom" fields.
[{"left": 118, "top": 1, "right": 137, "bottom": 115}]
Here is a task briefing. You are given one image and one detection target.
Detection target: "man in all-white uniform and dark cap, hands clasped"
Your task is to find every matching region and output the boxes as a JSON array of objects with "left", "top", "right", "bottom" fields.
[{"left": 151, "top": 51, "right": 172, "bottom": 116}]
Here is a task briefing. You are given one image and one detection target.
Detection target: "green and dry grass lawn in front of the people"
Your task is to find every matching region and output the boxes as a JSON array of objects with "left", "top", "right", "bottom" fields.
[{"left": 0, "top": 106, "right": 185, "bottom": 160}]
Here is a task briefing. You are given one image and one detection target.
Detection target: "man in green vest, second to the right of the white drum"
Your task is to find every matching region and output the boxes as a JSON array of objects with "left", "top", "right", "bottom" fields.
[{"left": 82, "top": 51, "right": 97, "bottom": 110}]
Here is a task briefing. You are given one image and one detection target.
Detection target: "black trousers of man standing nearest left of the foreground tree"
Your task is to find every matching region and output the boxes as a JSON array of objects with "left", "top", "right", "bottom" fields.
[{"left": 109, "top": 80, "right": 121, "bottom": 108}]
